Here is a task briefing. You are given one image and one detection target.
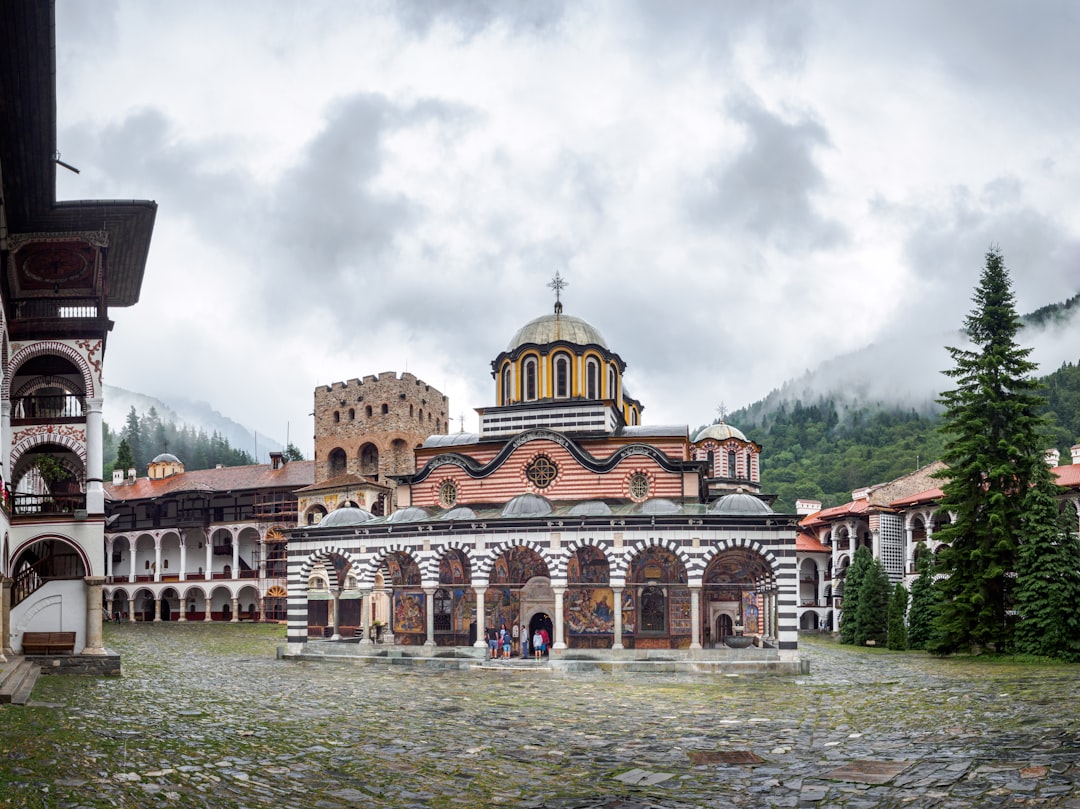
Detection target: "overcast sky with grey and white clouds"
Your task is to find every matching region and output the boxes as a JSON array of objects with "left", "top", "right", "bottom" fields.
[{"left": 56, "top": 0, "right": 1080, "bottom": 454}]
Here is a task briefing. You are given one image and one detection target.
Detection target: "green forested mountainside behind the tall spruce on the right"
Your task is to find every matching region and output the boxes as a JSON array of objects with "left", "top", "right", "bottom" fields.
[{"left": 728, "top": 358, "right": 1080, "bottom": 513}]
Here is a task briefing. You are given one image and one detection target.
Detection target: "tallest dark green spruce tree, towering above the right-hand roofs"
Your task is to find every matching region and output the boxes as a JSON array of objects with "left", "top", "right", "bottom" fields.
[{"left": 927, "top": 248, "right": 1044, "bottom": 655}]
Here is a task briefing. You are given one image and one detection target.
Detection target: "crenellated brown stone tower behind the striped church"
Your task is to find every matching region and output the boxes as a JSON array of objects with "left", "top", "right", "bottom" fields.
[{"left": 315, "top": 370, "right": 449, "bottom": 486}]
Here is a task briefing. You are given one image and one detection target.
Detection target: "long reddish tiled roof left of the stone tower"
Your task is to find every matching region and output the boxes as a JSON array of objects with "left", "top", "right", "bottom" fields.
[{"left": 105, "top": 461, "right": 315, "bottom": 500}]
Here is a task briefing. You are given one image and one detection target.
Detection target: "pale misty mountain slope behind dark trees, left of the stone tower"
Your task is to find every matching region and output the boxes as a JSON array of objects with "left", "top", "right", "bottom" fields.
[{"left": 103, "top": 385, "right": 285, "bottom": 463}]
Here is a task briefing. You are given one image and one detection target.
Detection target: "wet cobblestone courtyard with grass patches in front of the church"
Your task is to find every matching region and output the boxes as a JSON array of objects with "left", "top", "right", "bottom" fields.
[{"left": 0, "top": 624, "right": 1080, "bottom": 809}]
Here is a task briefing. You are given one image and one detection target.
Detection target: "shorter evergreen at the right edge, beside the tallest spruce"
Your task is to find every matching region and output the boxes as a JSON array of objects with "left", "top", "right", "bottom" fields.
[{"left": 1015, "top": 477, "right": 1080, "bottom": 660}]
